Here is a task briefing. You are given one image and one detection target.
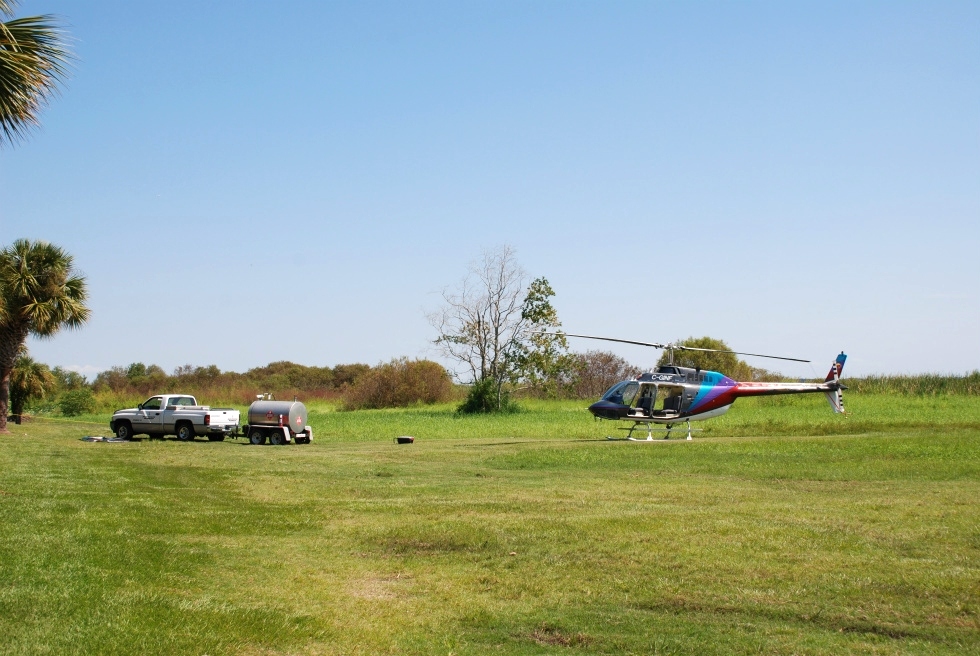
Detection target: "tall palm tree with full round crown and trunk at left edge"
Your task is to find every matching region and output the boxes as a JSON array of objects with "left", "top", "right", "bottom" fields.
[{"left": 0, "top": 239, "right": 89, "bottom": 433}]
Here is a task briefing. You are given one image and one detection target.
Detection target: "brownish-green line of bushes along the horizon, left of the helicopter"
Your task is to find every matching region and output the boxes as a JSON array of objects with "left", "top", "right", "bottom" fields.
[{"left": 10, "top": 350, "right": 640, "bottom": 422}]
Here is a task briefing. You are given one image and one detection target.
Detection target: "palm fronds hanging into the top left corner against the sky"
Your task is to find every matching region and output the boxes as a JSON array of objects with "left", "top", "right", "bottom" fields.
[{"left": 0, "top": 0, "right": 72, "bottom": 145}]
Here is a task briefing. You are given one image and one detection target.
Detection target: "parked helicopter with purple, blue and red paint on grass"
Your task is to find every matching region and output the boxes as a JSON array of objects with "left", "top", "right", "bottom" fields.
[{"left": 548, "top": 333, "right": 847, "bottom": 442}]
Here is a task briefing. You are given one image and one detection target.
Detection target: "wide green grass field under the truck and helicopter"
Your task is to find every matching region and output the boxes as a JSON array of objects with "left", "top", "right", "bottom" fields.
[{"left": 0, "top": 395, "right": 980, "bottom": 655}]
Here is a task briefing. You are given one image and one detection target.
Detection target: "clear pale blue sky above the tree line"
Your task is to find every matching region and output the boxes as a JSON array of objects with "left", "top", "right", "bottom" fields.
[{"left": 0, "top": 0, "right": 980, "bottom": 376}]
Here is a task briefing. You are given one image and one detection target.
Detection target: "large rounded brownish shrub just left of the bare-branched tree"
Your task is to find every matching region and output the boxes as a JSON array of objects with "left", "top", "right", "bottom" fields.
[{"left": 344, "top": 358, "right": 453, "bottom": 410}]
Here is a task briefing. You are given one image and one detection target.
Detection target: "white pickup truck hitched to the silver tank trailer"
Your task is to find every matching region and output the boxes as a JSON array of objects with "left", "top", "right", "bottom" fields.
[{"left": 109, "top": 394, "right": 239, "bottom": 442}]
